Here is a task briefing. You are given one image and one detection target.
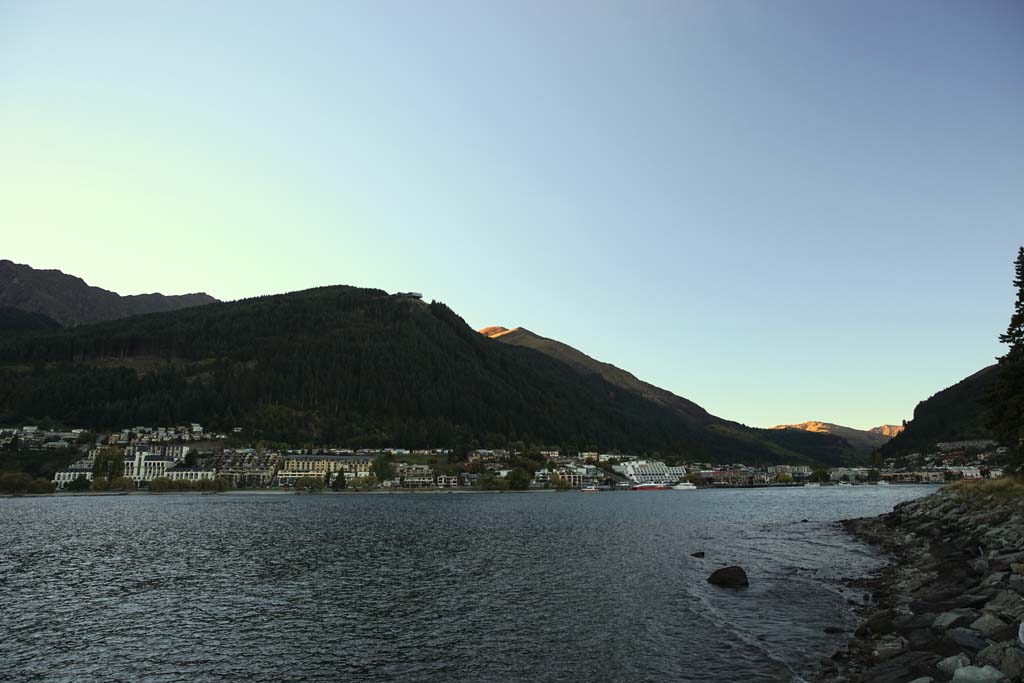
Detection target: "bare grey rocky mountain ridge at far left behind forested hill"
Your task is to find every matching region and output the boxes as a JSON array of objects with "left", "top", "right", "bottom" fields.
[{"left": 0, "top": 260, "right": 217, "bottom": 327}]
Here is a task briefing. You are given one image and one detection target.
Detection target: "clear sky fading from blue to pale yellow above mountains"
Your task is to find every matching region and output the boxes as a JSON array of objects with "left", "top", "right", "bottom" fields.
[{"left": 0, "top": 0, "right": 1024, "bottom": 428}]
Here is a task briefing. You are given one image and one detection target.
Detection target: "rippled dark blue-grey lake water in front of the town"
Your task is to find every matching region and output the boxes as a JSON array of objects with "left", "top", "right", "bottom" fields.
[{"left": 0, "top": 486, "right": 934, "bottom": 683}]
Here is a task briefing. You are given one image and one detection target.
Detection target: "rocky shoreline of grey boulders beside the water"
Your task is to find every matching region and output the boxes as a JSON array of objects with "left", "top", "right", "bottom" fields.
[{"left": 815, "top": 486, "right": 1024, "bottom": 683}]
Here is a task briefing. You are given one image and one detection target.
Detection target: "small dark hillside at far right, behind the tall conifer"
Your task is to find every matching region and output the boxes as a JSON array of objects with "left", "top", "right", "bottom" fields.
[{"left": 880, "top": 365, "right": 998, "bottom": 458}]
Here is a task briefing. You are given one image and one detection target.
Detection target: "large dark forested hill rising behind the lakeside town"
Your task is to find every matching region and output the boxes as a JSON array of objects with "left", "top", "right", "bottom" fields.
[{"left": 0, "top": 287, "right": 849, "bottom": 462}]
